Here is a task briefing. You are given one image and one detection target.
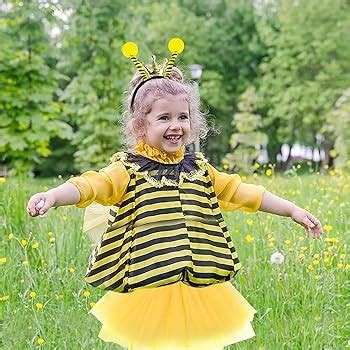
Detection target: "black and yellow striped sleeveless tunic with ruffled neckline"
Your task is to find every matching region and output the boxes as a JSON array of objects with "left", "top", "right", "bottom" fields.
[{"left": 86, "top": 153, "right": 240, "bottom": 293}]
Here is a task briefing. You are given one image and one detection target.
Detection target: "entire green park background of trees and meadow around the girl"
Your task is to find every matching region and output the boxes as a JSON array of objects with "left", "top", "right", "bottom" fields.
[{"left": 0, "top": 0, "right": 350, "bottom": 350}]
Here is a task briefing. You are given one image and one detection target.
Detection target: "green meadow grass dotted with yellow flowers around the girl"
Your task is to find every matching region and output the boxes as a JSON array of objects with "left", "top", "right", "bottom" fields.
[{"left": 0, "top": 172, "right": 350, "bottom": 350}]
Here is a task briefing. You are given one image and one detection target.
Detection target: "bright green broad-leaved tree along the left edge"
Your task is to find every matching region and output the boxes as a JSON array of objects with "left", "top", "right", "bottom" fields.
[{"left": 0, "top": 2, "right": 72, "bottom": 172}]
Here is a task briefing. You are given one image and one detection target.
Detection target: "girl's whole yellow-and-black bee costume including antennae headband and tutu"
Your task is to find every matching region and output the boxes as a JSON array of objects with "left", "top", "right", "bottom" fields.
[{"left": 68, "top": 39, "right": 264, "bottom": 350}]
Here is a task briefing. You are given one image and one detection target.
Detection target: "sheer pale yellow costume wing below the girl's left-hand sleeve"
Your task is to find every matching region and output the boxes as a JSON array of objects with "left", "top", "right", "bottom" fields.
[{"left": 83, "top": 203, "right": 111, "bottom": 244}]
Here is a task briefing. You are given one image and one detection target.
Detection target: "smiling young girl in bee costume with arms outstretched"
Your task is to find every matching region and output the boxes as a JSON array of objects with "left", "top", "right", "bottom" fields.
[{"left": 28, "top": 39, "right": 322, "bottom": 350}]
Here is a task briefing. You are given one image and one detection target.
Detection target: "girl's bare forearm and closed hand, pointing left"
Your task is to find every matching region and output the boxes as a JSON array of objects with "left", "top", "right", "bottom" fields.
[{"left": 27, "top": 182, "right": 80, "bottom": 216}]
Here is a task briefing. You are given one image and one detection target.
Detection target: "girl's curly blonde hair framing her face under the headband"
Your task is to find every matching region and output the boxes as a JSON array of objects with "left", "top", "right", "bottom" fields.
[{"left": 122, "top": 67, "right": 209, "bottom": 151}]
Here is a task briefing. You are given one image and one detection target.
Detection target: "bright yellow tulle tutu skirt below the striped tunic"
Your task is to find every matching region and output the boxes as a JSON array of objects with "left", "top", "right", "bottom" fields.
[{"left": 90, "top": 282, "right": 256, "bottom": 350}]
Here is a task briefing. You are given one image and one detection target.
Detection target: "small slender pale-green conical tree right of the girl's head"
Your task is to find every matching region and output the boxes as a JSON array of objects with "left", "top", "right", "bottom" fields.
[{"left": 223, "top": 86, "right": 268, "bottom": 173}]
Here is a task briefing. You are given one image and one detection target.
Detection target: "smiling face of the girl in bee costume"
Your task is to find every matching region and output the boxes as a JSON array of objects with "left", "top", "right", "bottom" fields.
[{"left": 144, "top": 94, "right": 190, "bottom": 153}]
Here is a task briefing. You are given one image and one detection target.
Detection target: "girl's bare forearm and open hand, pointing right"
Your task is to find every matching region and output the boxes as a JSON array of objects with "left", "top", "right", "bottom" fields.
[{"left": 259, "top": 191, "right": 323, "bottom": 238}]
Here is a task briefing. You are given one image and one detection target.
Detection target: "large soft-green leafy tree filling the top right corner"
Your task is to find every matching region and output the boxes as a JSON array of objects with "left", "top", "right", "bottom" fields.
[{"left": 258, "top": 0, "right": 350, "bottom": 159}]
